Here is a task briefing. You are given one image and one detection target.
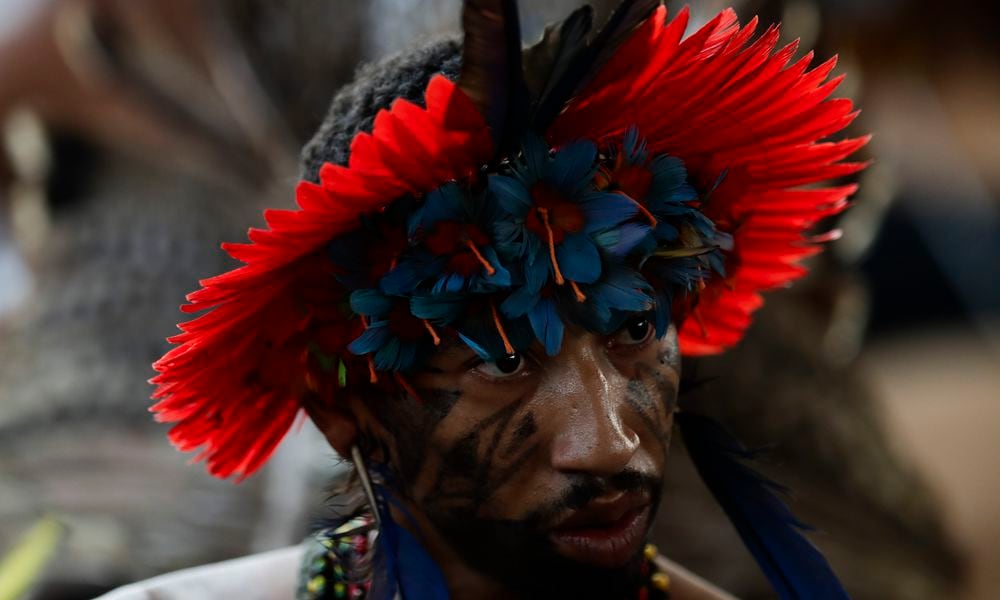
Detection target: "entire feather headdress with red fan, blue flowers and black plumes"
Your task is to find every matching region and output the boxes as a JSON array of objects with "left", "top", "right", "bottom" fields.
[{"left": 153, "top": 0, "right": 868, "bottom": 477}]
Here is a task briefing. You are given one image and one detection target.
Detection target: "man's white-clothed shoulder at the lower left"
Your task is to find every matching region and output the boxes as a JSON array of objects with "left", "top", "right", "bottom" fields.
[{"left": 98, "top": 546, "right": 303, "bottom": 600}]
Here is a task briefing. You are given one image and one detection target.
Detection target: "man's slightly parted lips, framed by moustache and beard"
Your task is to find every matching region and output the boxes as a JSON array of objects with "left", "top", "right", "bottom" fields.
[{"left": 549, "top": 494, "right": 650, "bottom": 568}]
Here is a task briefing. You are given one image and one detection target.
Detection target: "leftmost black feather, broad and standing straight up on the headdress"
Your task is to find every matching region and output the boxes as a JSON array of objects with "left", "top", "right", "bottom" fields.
[{"left": 458, "top": 0, "right": 528, "bottom": 156}]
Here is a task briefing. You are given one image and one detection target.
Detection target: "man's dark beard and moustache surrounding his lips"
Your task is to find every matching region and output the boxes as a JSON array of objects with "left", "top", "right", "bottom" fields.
[{"left": 427, "top": 471, "right": 663, "bottom": 600}]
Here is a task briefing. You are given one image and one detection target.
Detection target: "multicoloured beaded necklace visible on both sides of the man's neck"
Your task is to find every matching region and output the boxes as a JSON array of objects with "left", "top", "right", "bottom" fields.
[{"left": 295, "top": 514, "right": 670, "bottom": 600}]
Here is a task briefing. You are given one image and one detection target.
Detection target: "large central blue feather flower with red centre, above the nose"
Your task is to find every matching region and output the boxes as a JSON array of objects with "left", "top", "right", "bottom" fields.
[{"left": 489, "top": 135, "right": 647, "bottom": 355}]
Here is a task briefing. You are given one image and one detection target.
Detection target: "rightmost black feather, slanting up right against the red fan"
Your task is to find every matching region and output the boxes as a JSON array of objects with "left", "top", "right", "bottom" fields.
[{"left": 529, "top": 0, "right": 661, "bottom": 131}]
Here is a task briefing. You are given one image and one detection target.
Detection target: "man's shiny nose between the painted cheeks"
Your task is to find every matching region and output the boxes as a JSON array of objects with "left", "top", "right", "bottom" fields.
[{"left": 550, "top": 336, "right": 639, "bottom": 475}]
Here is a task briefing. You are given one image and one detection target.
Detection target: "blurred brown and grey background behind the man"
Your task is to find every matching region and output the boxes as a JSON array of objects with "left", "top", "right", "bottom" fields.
[{"left": 0, "top": 0, "right": 1000, "bottom": 600}]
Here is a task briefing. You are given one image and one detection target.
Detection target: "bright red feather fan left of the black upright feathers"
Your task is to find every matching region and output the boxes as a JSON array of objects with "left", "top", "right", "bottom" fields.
[{"left": 152, "top": 76, "right": 492, "bottom": 479}]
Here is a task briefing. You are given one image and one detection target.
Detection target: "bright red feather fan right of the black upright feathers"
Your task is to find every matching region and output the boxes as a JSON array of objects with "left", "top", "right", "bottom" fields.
[{"left": 547, "top": 7, "right": 869, "bottom": 355}]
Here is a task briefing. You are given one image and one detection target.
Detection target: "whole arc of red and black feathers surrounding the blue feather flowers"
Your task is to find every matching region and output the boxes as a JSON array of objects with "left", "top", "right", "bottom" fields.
[{"left": 152, "top": 2, "right": 868, "bottom": 478}]
